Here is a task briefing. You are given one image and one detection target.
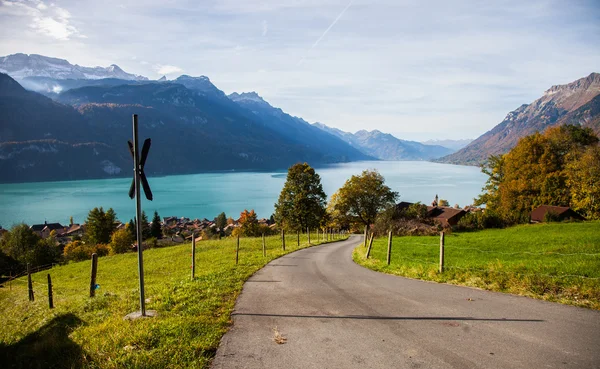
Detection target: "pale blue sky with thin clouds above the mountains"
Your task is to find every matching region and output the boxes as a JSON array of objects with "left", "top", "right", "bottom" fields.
[{"left": 0, "top": 0, "right": 600, "bottom": 141}]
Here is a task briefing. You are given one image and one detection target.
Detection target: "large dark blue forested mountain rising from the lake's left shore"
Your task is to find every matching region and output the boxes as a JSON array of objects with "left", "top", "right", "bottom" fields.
[{"left": 0, "top": 70, "right": 376, "bottom": 182}]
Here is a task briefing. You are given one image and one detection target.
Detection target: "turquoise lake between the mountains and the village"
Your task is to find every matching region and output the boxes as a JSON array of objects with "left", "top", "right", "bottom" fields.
[{"left": 0, "top": 161, "right": 487, "bottom": 228}]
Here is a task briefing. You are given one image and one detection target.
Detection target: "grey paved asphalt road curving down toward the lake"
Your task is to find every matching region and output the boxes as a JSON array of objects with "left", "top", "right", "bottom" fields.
[{"left": 213, "top": 236, "right": 600, "bottom": 369}]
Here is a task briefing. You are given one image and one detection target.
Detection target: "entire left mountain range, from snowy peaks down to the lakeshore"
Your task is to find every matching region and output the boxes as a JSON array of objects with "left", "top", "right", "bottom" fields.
[{"left": 0, "top": 54, "right": 462, "bottom": 182}]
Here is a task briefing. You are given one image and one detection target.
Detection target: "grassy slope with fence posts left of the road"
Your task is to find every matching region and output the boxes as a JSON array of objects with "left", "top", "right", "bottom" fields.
[{"left": 0, "top": 233, "right": 346, "bottom": 368}]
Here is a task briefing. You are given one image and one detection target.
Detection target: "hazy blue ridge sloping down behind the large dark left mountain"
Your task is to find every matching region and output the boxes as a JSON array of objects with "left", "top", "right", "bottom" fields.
[{"left": 229, "top": 92, "right": 373, "bottom": 161}]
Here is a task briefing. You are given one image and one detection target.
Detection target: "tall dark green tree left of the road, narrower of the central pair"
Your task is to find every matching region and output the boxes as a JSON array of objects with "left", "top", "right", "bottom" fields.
[{"left": 275, "top": 163, "right": 327, "bottom": 230}]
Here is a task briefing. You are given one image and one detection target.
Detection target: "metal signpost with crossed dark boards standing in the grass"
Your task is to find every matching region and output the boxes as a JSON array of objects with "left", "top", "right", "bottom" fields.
[{"left": 125, "top": 114, "right": 156, "bottom": 319}]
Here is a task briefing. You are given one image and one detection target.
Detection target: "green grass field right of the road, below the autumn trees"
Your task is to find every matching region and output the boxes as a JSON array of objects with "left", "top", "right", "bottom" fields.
[{"left": 353, "top": 221, "right": 600, "bottom": 310}]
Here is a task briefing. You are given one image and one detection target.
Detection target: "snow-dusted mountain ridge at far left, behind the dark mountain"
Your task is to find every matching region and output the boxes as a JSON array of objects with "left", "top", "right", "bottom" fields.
[{"left": 0, "top": 53, "right": 148, "bottom": 80}]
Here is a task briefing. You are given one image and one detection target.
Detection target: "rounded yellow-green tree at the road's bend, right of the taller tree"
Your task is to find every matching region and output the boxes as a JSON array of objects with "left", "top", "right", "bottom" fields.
[{"left": 333, "top": 170, "right": 398, "bottom": 226}]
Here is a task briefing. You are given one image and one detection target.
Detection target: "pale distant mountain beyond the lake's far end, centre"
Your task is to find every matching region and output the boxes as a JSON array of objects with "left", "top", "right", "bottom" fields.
[{"left": 314, "top": 123, "right": 452, "bottom": 160}]
